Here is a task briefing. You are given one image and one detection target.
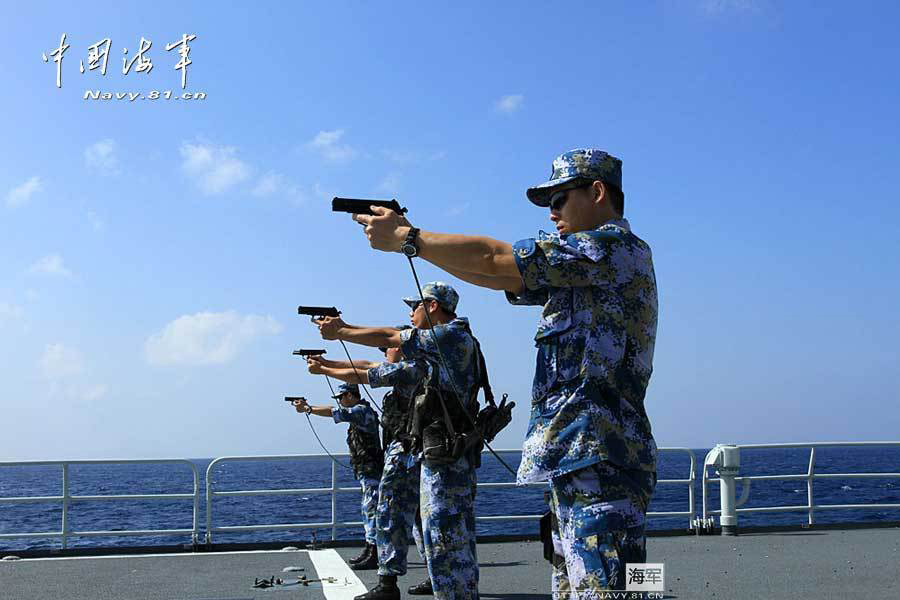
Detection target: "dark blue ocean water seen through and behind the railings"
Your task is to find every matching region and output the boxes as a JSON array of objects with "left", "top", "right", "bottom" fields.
[{"left": 0, "top": 446, "right": 900, "bottom": 550}]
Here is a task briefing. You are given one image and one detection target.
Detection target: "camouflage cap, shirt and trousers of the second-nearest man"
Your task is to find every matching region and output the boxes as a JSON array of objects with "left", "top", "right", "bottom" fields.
[{"left": 400, "top": 282, "right": 479, "bottom": 600}]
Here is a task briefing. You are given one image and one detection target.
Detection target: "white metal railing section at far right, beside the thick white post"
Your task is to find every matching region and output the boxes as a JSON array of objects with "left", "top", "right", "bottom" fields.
[{"left": 702, "top": 441, "right": 900, "bottom": 533}]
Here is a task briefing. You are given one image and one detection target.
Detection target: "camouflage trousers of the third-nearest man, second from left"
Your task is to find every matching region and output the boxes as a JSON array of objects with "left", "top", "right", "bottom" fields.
[{"left": 375, "top": 442, "right": 424, "bottom": 575}]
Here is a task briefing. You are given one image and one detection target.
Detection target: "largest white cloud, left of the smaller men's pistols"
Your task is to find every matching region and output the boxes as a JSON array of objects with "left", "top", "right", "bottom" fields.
[{"left": 144, "top": 311, "right": 281, "bottom": 365}]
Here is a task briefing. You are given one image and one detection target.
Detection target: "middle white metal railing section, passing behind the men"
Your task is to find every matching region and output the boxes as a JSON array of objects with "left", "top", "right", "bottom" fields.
[{"left": 206, "top": 448, "right": 697, "bottom": 543}]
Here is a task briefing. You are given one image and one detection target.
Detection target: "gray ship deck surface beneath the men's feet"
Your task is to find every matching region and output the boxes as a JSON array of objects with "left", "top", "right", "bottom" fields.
[{"left": 0, "top": 528, "right": 900, "bottom": 600}]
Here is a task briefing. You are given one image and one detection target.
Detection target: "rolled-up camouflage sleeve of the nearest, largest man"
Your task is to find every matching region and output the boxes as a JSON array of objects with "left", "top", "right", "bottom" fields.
[{"left": 507, "top": 230, "right": 622, "bottom": 290}]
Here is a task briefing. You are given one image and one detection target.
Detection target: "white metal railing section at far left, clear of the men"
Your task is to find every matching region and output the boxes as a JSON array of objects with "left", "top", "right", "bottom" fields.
[{"left": 0, "top": 459, "right": 200, "bottom": 549}]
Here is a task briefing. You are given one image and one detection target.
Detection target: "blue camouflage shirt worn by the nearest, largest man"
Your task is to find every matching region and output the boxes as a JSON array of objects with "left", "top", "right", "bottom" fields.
[{"left": 507, "top": 219, "right": 657, "bottom": 483}]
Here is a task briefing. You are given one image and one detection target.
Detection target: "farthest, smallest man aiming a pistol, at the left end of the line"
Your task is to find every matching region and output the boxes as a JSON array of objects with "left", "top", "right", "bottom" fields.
[{"left": 294, "top": 383, "right": 384, "bottom": 570}]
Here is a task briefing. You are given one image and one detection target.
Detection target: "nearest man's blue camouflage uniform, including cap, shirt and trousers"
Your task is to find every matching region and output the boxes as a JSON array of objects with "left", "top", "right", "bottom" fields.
[{"left": 507, "top": 150, "right": 657, "bottom": 599}]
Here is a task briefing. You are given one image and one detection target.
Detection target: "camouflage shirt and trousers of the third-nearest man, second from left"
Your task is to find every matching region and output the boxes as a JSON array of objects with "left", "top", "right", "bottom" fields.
[{"left": 368, "top": 360, "right": 428, "bottom": 575}]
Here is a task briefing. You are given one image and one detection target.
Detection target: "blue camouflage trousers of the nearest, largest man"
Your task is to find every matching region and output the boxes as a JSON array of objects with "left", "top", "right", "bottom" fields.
[{"left": 550, "top": 462, "right": 656, "bottom": 600}]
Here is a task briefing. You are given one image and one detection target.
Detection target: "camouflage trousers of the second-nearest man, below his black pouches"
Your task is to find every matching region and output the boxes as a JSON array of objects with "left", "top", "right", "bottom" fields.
[{"left": 421, "top": 457, "right": 478, "bottom": 600}]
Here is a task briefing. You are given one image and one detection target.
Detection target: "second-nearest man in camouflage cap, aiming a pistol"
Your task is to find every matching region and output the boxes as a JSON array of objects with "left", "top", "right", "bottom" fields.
[{"left": 316, "top": 282, "right": 480, "bottom": 600}]
